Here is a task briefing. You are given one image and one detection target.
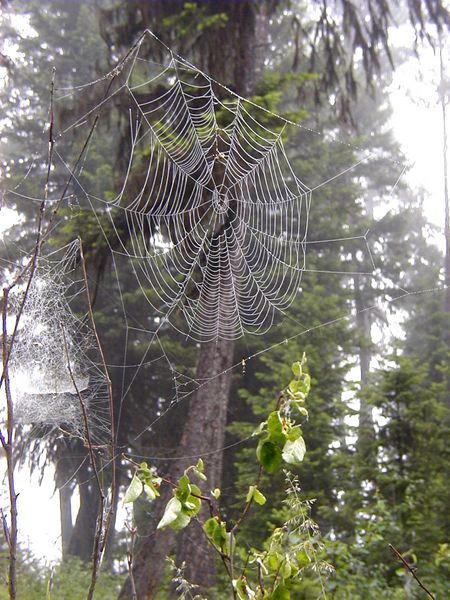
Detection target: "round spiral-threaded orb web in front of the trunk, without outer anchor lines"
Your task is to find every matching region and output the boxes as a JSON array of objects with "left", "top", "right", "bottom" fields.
[{"left": 52, "top": 34, "right": 374, "bottom": 342}]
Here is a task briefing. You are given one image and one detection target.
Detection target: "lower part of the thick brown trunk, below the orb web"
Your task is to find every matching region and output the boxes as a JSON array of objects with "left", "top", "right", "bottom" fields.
[{"left": 120, "top": 340, "right": 234, "bottom": 600}]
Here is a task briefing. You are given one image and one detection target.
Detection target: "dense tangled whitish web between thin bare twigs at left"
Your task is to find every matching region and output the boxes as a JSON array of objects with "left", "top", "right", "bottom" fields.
[{"left": 9, "top": 242, "right": 110, "bottom": 445}]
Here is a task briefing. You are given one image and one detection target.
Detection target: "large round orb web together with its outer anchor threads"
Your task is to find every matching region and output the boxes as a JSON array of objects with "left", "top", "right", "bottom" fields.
[{"left": 0, "top": 32, "right": 412, "bottom": 450}]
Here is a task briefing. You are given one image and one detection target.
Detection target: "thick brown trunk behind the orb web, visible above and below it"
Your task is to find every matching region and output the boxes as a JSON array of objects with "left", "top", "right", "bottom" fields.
[{"left": 116, "top": 0, "right": 277, "bottom": 600}]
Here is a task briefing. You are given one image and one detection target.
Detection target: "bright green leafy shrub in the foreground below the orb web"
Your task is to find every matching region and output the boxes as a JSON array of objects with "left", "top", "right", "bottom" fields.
[{"left": 125, "top": 358, "right": 331, "bottom": 600}]
